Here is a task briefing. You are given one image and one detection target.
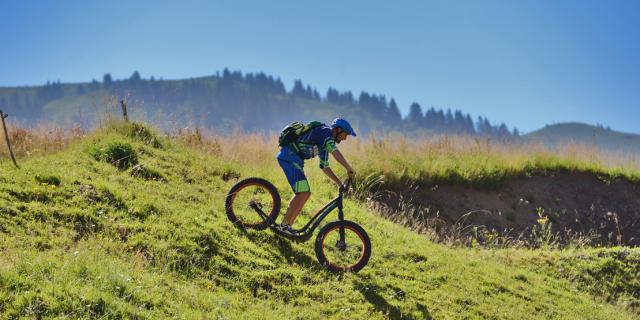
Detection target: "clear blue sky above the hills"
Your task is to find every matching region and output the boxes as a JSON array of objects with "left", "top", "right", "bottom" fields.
[{"left": 0, "top": 0, "right": 640, "bottom": 133}]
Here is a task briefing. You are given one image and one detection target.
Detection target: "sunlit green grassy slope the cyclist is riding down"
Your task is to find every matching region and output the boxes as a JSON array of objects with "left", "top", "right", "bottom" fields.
[{"left": 0, "top": 123, "right": 640, "bottom": 319}]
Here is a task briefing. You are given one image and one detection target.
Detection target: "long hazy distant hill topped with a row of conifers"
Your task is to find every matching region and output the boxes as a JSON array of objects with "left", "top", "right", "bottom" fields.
[{"left": 0, "top": 69, "right": 518, "bottom": 138}]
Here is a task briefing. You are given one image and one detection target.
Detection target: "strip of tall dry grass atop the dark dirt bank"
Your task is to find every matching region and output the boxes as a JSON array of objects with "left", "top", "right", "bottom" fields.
[{"left": 346, "top": 135, "right": 640, "bottom": 182}]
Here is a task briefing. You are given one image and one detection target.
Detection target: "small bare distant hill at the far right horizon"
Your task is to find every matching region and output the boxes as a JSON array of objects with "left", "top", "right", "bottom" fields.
[{"left": 523, "top": 122, "right": 640, "bottom": 154}]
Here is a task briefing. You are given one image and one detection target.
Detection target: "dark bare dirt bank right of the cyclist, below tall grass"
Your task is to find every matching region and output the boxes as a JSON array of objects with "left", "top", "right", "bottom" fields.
[{"left": 383, "top": 173, "right": 640, "bottom": 246}]
